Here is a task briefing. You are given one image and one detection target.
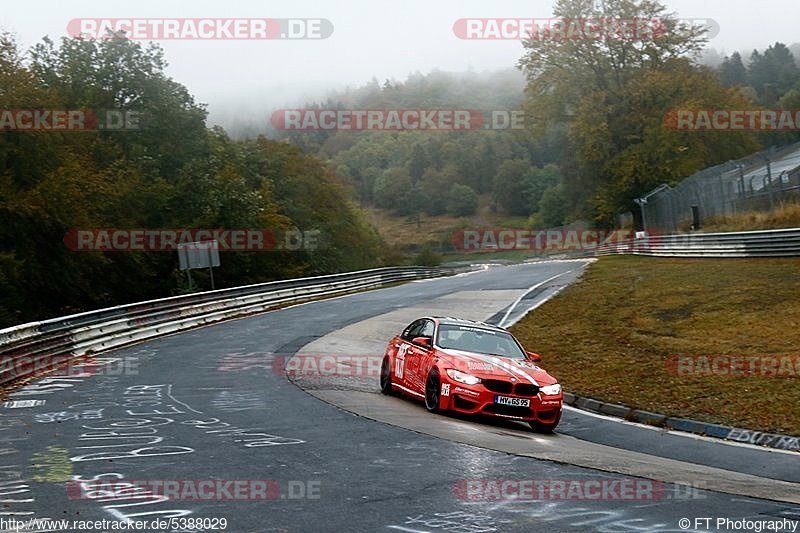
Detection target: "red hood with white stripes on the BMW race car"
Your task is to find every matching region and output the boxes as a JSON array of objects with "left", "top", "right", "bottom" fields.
[{"left": 437, "top": 348, "right": 558, "bottom": 386}]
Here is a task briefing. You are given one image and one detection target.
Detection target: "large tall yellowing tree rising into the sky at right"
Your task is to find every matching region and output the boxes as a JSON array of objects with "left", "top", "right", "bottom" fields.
[{"left": 519, "top": 0, "right": 757, "bottom": 225}]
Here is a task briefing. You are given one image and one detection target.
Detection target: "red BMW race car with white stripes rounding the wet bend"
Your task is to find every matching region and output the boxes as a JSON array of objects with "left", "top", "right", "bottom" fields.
[{"left": 380, "top": 317, "right": 564, "bottom": 432}]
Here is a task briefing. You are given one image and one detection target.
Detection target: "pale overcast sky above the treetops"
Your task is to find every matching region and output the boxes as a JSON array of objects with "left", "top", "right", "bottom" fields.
[{"left": 0, "top": 0, "right": 800, "bottom": 123}]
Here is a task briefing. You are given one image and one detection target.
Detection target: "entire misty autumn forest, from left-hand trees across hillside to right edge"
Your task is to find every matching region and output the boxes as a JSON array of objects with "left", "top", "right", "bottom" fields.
[{"left": 0, "top": 0, "right": 800, "bottom": 327}]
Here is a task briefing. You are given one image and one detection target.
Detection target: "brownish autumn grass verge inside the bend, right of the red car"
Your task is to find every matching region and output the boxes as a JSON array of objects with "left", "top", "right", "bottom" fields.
[{"left": 512, "top": 256, "right": 800, "bottom": 435}]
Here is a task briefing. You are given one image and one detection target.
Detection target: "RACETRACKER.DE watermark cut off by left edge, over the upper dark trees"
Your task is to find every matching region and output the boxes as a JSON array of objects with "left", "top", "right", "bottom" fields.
[{"left": 0, "top": 108, "right": 143, "bottom": 132}]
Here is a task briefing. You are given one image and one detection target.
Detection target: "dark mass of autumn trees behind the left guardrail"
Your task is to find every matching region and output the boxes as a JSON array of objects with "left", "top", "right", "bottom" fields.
[{"left": 0, "top": 35, "right": 381, "bottom": 327}]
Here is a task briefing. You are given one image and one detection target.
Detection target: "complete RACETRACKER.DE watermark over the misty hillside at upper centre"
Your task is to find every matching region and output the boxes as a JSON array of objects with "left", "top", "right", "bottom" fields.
[{"left": 270, "top": 109, "right": 525, "bottom": 131}]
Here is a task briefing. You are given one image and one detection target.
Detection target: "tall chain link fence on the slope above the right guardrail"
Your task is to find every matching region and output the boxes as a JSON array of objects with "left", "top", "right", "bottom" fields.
[{"left": 637, "top": 143, "right": 800, "bottom": 233}]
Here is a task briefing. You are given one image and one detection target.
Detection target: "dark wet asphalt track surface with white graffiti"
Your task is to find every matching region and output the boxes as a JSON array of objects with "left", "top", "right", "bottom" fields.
[{"left": 0, "top": 262, "right": 800, "bottom": 533}]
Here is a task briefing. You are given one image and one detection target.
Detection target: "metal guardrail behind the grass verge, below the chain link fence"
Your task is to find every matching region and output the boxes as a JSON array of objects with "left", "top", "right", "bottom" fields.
[{"left": 596, "top": 228, "right": 800, "bottom": 257}]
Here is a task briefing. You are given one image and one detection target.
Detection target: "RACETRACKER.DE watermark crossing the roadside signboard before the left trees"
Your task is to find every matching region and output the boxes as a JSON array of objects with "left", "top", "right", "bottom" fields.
[{"left": 64, "top": 228, "right": 324, "bottom": 252}]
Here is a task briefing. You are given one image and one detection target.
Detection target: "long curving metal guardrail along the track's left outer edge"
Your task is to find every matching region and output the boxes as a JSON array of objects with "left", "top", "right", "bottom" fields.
[{"left": 0, "top": 267, "right": 454, "bottom": 385}]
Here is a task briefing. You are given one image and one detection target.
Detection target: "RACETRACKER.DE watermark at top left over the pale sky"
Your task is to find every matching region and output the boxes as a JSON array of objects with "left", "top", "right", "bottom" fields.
[{"left": 67, "top": 17, "right": 333, "bottom": 41}]
